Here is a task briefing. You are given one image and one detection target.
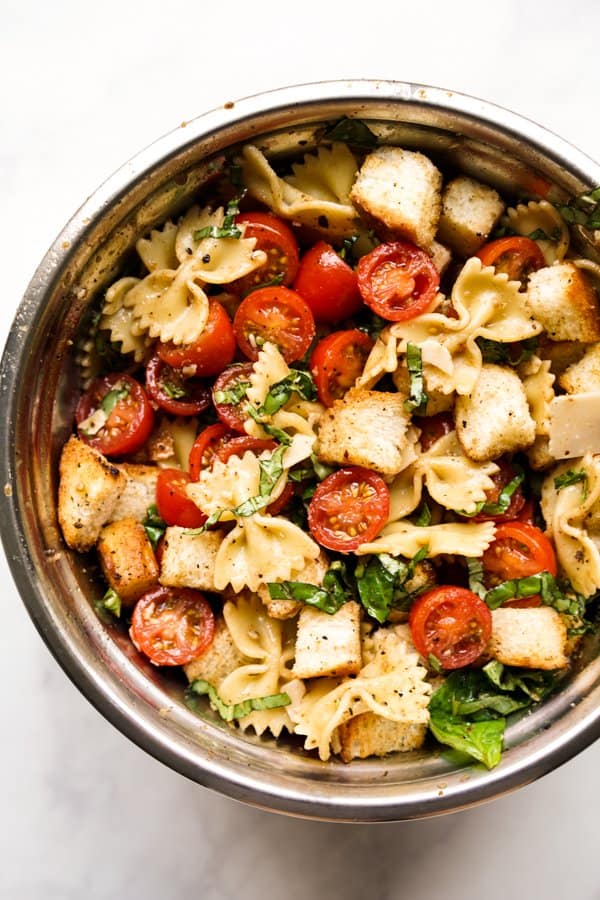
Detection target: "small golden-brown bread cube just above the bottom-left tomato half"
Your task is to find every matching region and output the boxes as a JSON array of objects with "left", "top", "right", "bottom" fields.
[{"left": 98, "top": 519, "right": 158, "bottom": 606}]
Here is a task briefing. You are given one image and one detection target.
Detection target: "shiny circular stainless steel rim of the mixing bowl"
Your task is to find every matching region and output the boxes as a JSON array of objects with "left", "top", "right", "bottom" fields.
[{"left": 0, "top": 79, "right": 600, "bottom": 822}]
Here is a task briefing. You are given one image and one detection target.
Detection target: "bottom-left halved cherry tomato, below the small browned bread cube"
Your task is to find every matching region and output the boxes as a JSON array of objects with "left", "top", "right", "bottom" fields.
[{"left": 129, "top": 587, "right": 215, "bottom": 666}]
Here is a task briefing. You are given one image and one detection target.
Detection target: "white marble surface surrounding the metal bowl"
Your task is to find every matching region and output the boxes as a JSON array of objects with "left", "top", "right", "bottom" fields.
[{"left": 0, "top": 0, "right": 600, "bottom": 900}]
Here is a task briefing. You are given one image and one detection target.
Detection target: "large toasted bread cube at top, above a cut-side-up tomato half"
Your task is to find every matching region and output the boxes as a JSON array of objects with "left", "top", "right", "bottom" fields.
[{"left": 350, "top": 147, "right": 442, "bottom": 250}]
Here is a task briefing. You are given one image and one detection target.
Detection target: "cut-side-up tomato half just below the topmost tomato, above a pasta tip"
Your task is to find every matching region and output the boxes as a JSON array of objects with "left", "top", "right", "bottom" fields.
[{"left": 233, "top": 287, "right": 315, "bottom": 363}]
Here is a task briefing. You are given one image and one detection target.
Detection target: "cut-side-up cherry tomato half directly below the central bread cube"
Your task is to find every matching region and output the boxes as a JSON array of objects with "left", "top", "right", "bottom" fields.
[{"left": 308, "top": 466, "right": 390, "bottom": 553}]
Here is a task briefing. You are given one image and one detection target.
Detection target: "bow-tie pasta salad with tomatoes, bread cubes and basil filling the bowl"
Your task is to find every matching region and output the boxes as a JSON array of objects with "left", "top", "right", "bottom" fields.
[{"left": 58, "top": 120, "right": 600, "bottom": 767}]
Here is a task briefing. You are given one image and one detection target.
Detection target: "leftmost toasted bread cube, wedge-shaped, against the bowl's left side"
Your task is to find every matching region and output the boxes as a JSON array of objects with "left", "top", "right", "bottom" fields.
[{"left": 58, "top": 436, "right": 126, "bottom": 553}]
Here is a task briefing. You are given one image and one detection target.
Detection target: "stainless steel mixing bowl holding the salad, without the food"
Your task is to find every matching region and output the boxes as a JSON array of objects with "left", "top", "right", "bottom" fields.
[{"left": 0, "top": 81, "right": 600, "bottom": 822}]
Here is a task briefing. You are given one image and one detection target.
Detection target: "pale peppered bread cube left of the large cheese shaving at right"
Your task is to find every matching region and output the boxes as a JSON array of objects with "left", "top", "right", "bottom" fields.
[{"left": 454, "top": 365, "right": 535, "bottom": 462}]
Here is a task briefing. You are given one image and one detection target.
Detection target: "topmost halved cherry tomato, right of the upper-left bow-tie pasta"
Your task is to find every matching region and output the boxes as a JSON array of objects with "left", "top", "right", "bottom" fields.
[{"left": 229, "top": 212, "right": 298, "bottom": 296}]
